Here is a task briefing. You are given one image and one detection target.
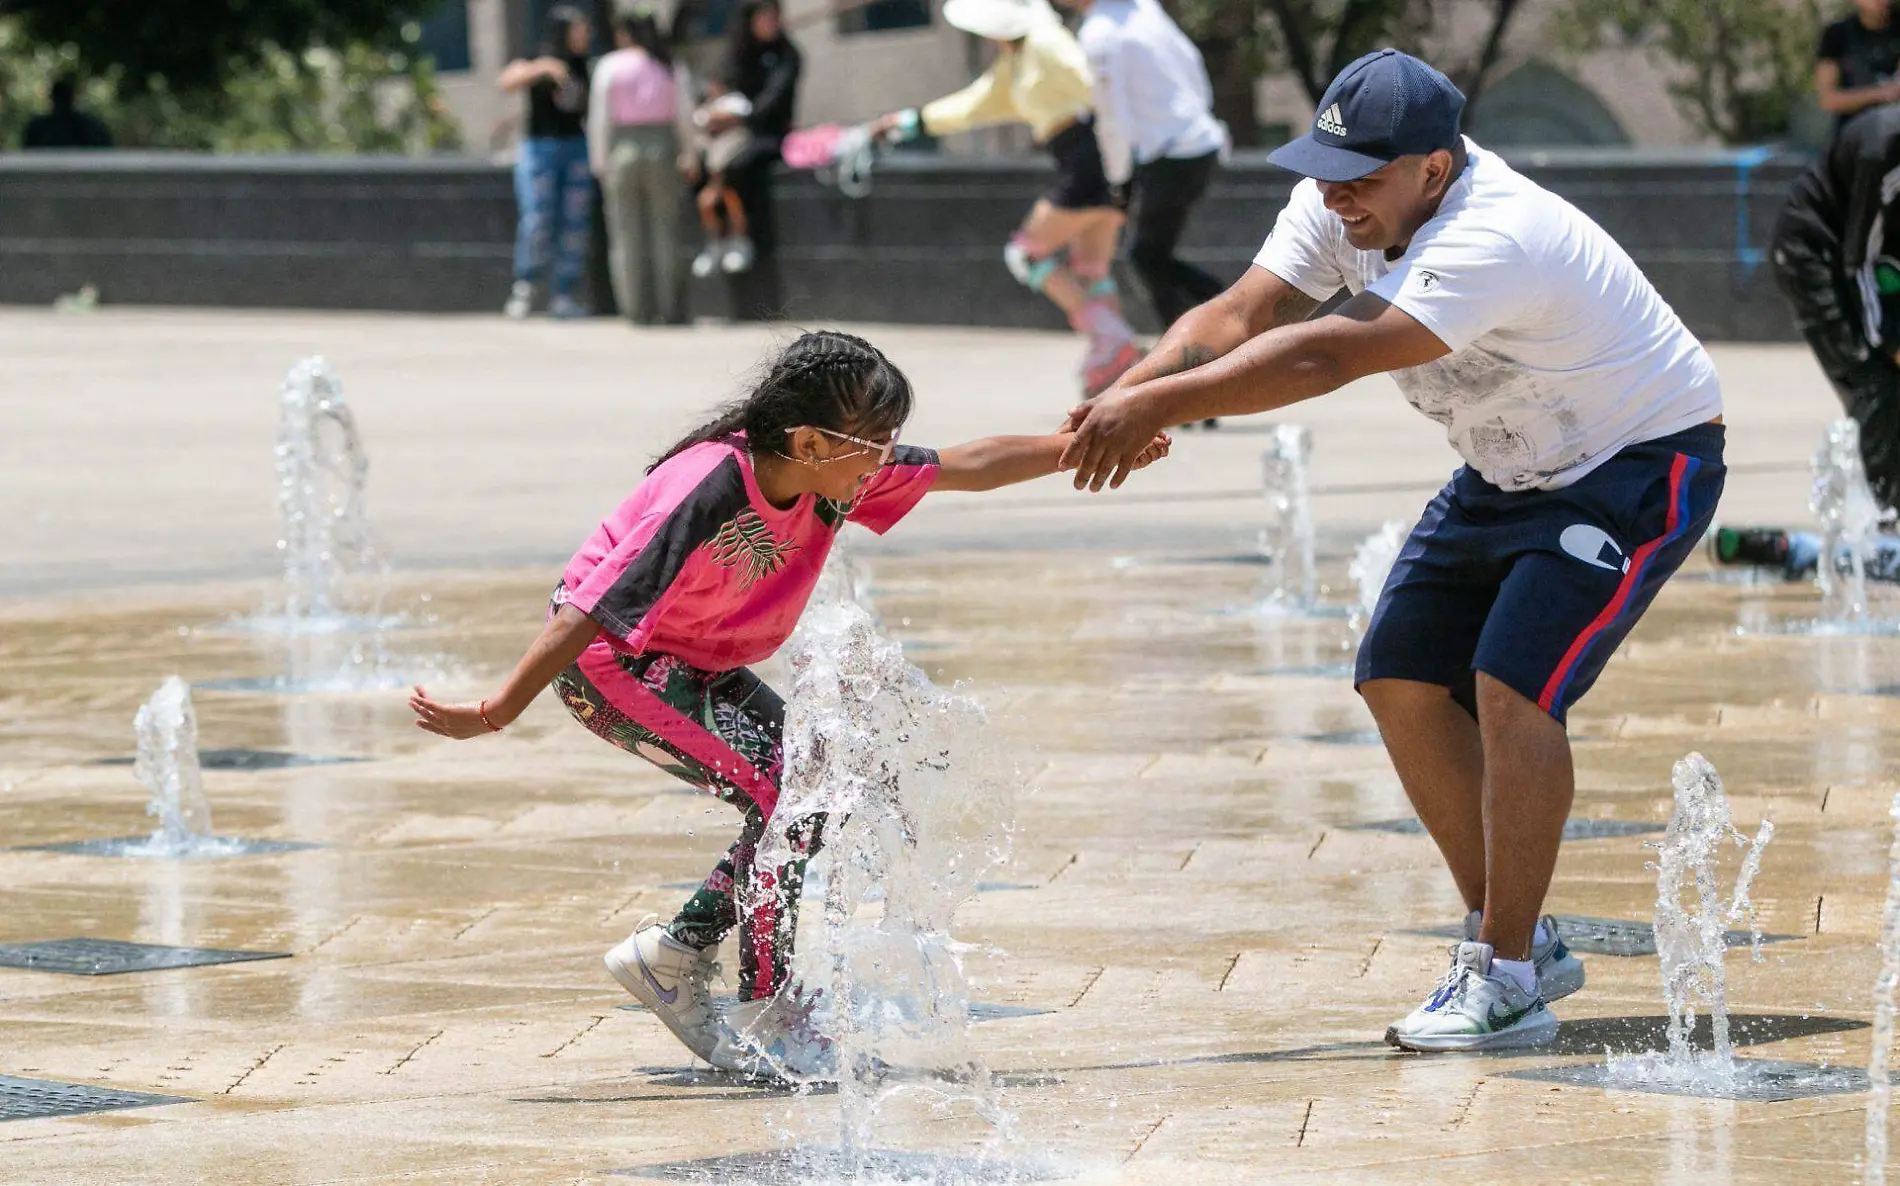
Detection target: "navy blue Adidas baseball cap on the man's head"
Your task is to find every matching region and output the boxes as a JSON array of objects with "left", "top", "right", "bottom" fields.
[{"left": 1267, "top": 49, "right": 1465, "bottom": 181}]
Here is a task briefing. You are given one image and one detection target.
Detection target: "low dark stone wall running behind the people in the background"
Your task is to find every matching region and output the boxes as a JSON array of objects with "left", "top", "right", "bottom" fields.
[{"left": 0, "top": 152, "right": 1801, "bottom": 340}]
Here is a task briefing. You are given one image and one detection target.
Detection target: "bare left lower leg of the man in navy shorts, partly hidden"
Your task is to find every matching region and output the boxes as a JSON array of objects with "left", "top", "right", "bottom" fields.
[{"left": 1359, "top": 679, "right": 1486, "bottom": 910}]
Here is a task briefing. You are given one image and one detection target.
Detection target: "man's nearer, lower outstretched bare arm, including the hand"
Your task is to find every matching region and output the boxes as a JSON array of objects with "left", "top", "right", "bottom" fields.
[{"left": 1064, "top": 293, "right": 1450, "bottom": 490}]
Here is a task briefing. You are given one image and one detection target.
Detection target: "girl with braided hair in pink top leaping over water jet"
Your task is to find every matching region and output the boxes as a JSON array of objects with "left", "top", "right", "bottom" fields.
[{"left": 409, "top": 331, "right": 1169, "bottom": 1078}]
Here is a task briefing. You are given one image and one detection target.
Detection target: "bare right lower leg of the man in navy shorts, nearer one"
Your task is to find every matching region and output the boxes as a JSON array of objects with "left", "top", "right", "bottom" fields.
[{"left": 1478, "top": 671, "right": 1577, "bottom": 960}]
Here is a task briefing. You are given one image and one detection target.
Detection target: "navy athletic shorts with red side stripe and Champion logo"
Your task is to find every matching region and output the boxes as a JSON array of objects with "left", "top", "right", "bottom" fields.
[{"left": 1353, "top": 424, "right": 1727, "bottom": 722}]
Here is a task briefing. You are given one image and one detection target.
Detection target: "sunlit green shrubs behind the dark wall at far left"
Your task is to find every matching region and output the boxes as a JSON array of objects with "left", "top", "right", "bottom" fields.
[{"left": 0, "top": 19, "right": 458, "bottom": 152}]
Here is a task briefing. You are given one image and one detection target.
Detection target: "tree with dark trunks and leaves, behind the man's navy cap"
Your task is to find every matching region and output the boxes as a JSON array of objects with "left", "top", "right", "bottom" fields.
[{"left": 1169, "top": 0, "right": 1524, "bottom": 144}]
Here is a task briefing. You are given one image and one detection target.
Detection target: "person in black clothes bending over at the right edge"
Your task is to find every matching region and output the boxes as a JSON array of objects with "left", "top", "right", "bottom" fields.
[{"left": 1769, "top": 106, "right": 1900, "bottom": 507}]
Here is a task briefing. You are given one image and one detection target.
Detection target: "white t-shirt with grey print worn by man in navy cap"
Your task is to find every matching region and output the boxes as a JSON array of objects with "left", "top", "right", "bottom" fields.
[{"left": 1254, "top": 139, "right": 1721, "bottom": 490}]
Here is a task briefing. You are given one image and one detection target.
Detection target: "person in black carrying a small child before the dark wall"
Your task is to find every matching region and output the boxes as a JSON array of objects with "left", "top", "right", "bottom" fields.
[{"left": 707, "top": 0, "right": 804, "bottom": 258}]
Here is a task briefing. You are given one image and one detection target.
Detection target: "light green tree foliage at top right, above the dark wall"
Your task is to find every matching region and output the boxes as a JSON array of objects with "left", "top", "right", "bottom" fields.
[{"left": 1560, "top": 0, "right": 1822, "bottom": 144}]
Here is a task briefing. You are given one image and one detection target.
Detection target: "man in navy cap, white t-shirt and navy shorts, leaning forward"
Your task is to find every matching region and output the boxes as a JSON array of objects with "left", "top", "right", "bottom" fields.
[{"left": 1064, "top": 49, "right": 1725, "bottom": 1051}]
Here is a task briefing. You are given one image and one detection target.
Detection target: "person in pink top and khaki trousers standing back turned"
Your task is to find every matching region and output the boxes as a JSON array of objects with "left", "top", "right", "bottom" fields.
[{"left": 587, "top": 10, "right": 692, "bottom": 325}]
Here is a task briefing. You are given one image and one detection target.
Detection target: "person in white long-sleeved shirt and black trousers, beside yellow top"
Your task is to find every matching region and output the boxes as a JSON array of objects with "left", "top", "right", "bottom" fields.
[{"left": 1060, "top": 0, "right": 1227, "bottom": 338}]
